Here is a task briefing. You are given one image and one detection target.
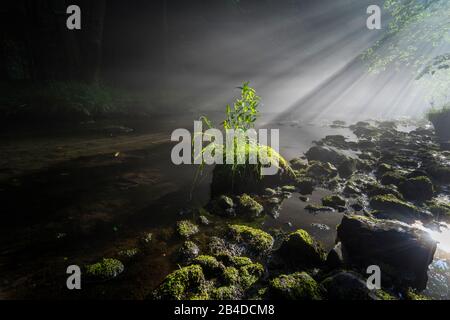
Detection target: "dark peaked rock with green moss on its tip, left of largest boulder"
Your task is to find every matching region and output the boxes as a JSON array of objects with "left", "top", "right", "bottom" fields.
[{"left": 277, "top": 229, "right": 325, "bottom": 267}]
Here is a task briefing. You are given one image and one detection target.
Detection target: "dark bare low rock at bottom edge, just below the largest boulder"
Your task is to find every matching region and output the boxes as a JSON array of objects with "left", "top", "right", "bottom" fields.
[{"left": 321, "top": 271, "right": 393, "bottom": 300}]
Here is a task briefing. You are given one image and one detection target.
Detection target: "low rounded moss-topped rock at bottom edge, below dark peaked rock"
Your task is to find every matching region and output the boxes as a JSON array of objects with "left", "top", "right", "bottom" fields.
[{"left": 269, "top": 272, "right": 322, "bottom": 300}]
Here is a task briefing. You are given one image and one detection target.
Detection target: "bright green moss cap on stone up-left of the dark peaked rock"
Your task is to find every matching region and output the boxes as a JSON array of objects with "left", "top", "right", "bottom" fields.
[{"left": 229, "top": 225, "right": 273, "bottom": 254}]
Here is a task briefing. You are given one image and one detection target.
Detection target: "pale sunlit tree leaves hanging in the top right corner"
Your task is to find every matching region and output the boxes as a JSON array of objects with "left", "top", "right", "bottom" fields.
[{"left": 362, "top": 0, "right": 450, "bottom": 105}]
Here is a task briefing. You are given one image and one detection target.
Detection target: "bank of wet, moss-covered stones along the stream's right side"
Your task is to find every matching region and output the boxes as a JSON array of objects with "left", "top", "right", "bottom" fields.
[{"left": 81, "top": 121, "right": 450, "bottom": 300}]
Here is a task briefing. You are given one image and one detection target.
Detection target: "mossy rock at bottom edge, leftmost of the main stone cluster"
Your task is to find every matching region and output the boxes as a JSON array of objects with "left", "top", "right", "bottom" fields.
[{"left": 154, "top": 265, "right": 205, "bottom": 300}]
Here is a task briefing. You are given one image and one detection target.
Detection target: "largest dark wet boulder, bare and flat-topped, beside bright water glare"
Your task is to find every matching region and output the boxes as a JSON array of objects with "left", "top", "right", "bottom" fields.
[{"left": 337, "top": 215, "right": 436, "bottom": 290}]
